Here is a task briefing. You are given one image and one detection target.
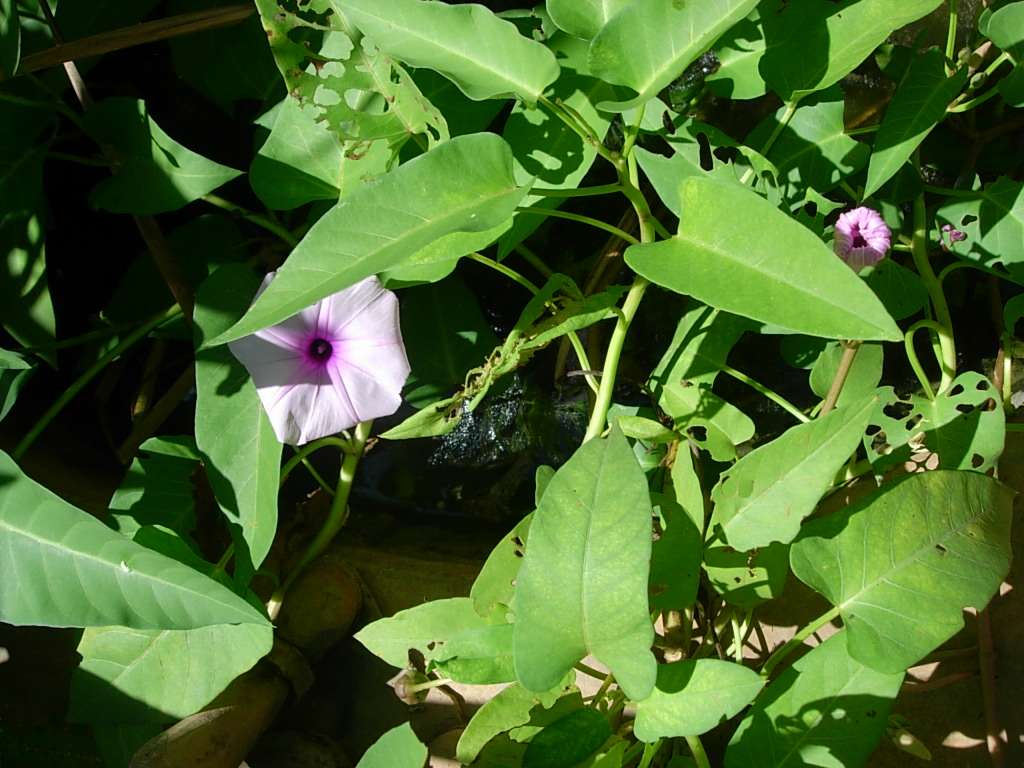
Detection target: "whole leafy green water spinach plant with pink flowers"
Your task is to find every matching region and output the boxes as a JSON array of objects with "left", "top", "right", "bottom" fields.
[{"left": 0, "top": 0, "right": 1024, "bottom": 768}]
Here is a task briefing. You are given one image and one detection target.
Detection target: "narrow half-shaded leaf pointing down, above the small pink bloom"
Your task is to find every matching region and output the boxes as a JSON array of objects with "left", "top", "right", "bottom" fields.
[{"left": 864, "top": 48, "right": 968, "bottom": 198}]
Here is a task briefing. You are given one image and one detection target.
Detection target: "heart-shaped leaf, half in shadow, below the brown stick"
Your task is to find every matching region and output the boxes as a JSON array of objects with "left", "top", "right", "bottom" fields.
[{"left": 86, "top": 98, "right": 241, "bottom": 215}]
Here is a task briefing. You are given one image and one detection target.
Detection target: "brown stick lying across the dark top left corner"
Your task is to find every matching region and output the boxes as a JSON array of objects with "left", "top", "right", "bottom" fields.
[{"left": 17, "top": 3, "right": 256, "bottom": 76}]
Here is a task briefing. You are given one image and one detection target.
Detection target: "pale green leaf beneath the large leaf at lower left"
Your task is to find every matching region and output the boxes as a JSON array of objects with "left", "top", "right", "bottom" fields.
[{"left": 68, "top": 624, "right": 273, "bottom": 724}]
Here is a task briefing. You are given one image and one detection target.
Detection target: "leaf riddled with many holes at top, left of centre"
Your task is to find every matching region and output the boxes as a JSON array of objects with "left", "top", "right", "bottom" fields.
[{"left": 250, "top": 0, "right": 449, "bottom": 148}]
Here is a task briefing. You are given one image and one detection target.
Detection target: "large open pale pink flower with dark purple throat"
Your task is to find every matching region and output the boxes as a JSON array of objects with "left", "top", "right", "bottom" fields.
[{"left": 228, "top": 272, "right": 409, "bottom": 445}]
